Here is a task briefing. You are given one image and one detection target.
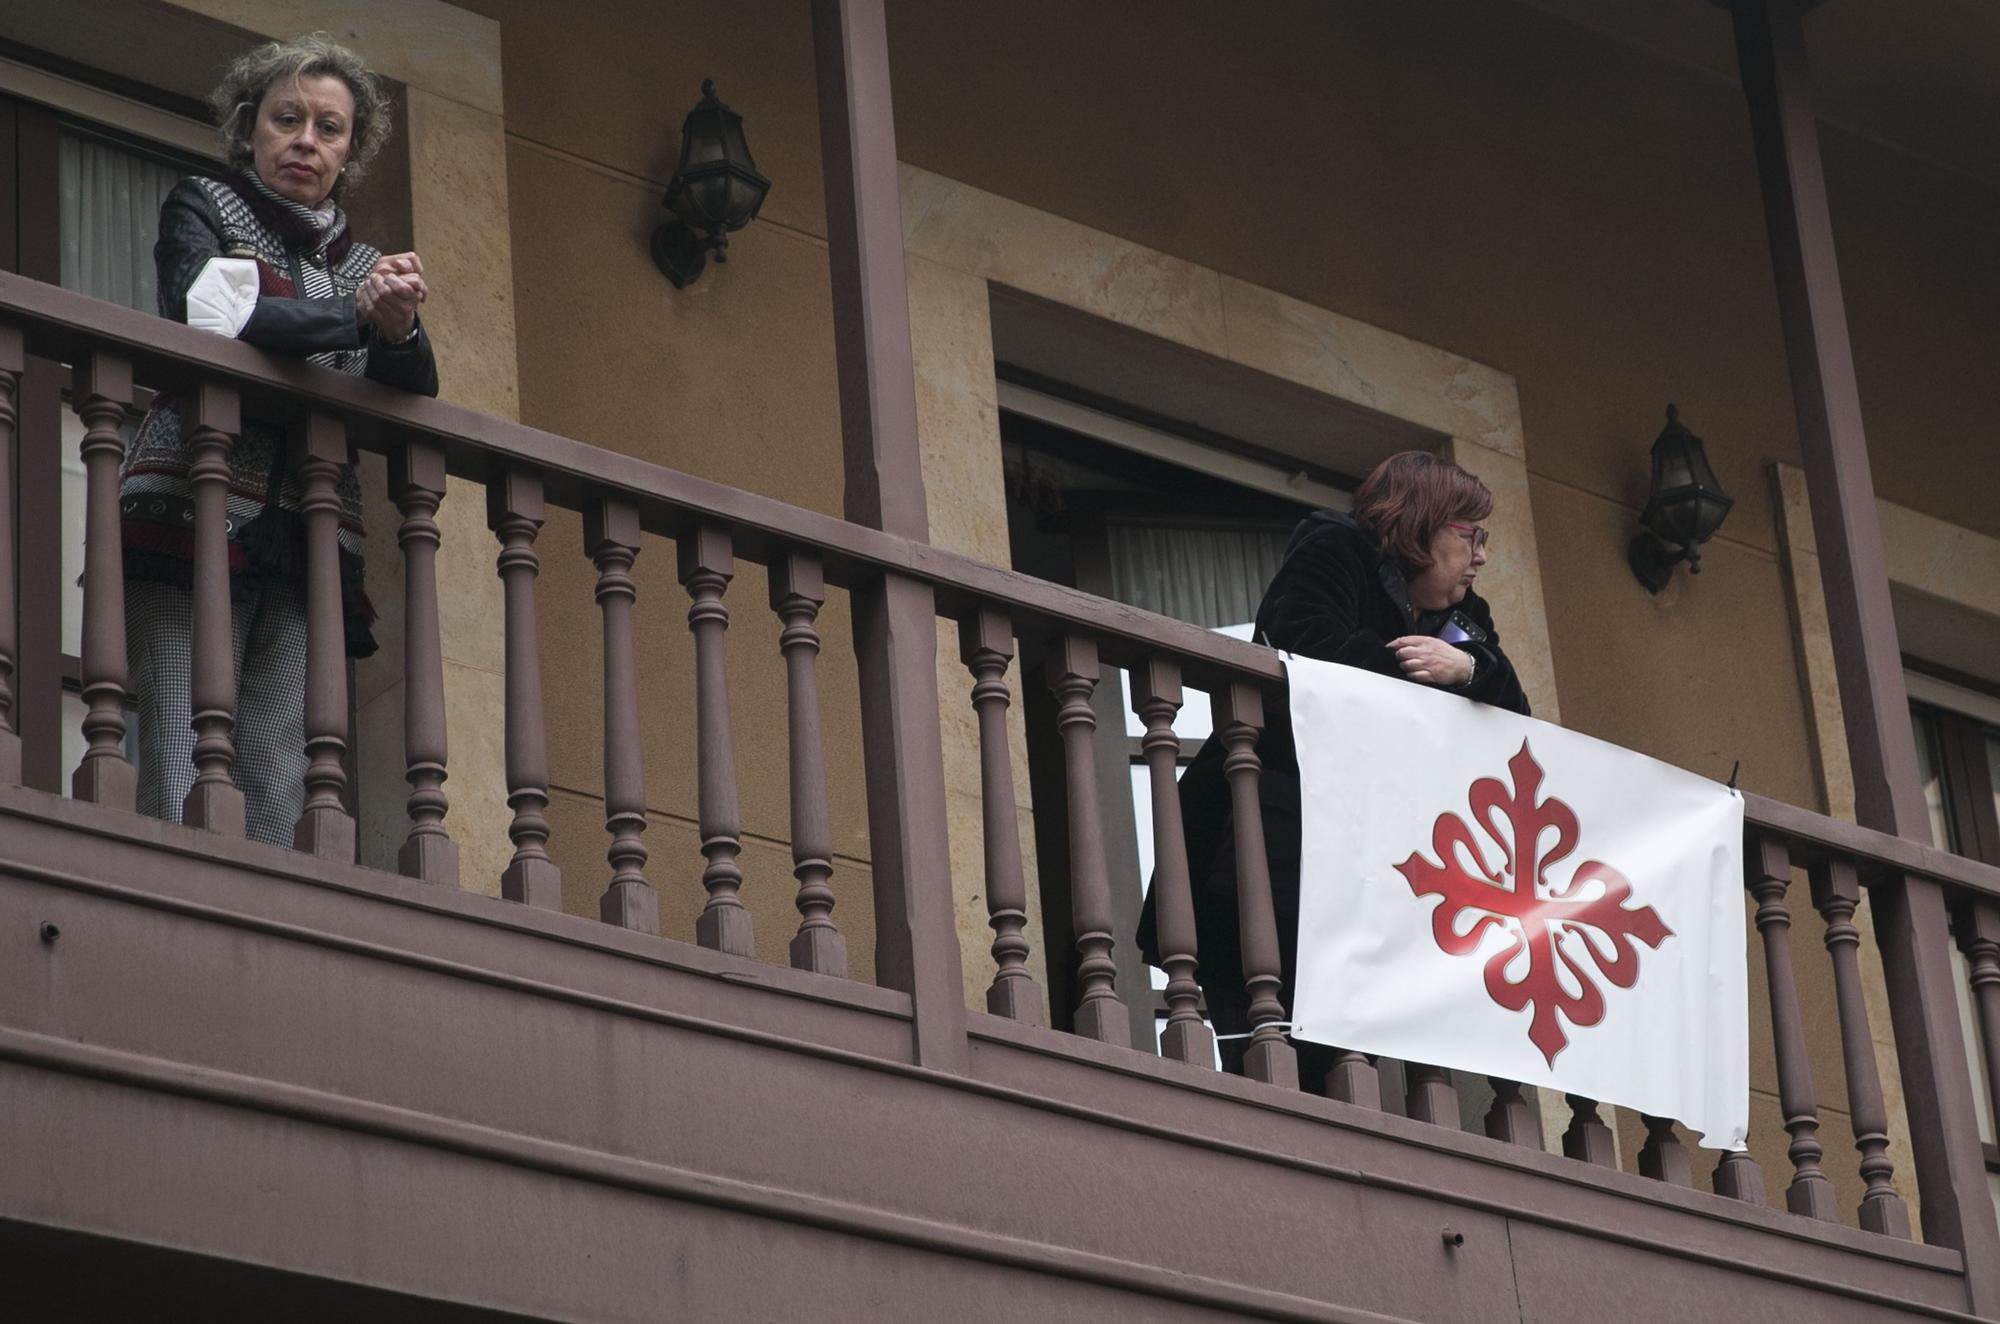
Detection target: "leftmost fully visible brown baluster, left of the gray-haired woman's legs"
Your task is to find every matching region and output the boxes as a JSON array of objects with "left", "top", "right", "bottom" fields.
[{"left": 70, "top": 354, "right": 138, "bottom": 810}]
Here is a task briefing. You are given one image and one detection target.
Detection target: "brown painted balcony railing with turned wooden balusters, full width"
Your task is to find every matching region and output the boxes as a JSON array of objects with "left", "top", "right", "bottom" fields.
[{"left": 0, "top": 274, "right": 2000, "bottom": 1288}]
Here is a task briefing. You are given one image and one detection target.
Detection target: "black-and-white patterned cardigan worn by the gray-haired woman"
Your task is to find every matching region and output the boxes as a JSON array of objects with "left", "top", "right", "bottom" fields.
[{"left": 120, "top": 174, "right": 438, "bottom": 656}]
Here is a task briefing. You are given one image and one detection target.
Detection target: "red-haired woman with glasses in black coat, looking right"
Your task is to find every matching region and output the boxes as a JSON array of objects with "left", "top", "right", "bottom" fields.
[{"left": 1138, "top": 450, "right": 1528, "bottom": 1094}]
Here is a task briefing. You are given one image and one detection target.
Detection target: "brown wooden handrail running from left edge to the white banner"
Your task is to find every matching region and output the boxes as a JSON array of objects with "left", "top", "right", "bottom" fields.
[{"left": 0, "top": 272, "right": 1284, "bottom": 688}]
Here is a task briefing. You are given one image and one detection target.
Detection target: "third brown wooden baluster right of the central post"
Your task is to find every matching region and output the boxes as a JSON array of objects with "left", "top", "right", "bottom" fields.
[{"left": 1132, "top": 656, "right": 1216, "bottom": 1068}]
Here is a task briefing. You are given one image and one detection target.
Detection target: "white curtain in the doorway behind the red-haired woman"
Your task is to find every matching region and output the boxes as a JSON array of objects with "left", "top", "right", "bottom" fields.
[{"left": 1104, "top": 518, "right": 1290, "bottom": 630}]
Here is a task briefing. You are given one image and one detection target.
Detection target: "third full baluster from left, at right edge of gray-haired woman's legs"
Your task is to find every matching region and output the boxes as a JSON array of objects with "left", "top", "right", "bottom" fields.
[{"left": 292, "top": 412, "right": 354, "bottom": 864}]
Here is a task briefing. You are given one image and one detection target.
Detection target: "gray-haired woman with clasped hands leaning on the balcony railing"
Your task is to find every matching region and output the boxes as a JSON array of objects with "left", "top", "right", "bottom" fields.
[{"left": 120, "top": 32, "right": 438, "bottom": 844}]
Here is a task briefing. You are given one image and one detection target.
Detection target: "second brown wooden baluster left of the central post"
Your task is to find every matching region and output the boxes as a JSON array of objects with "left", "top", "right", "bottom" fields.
[{"left": 678, "top": 526, "right": 756, "bottom": 956}]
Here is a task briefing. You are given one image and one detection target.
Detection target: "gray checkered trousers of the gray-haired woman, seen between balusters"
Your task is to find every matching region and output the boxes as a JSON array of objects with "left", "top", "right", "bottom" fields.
[{"left": 126, "top": 576, "right": 306, "bottom": 846}]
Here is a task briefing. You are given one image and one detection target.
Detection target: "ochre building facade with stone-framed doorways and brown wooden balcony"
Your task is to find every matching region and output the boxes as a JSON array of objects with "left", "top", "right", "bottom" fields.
[{"left": 0, "top": 0, "right": 2000, "bottom": 1320}]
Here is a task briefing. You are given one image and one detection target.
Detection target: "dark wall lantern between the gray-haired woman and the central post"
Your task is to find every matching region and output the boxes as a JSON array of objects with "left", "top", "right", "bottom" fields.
[{"left": 652, "top": 78, "right": 770, "bottom": 290}]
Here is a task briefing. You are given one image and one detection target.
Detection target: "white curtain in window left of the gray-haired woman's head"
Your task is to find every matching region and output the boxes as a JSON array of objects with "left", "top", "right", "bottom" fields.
[{"left": 56, "top": 132, "right": 182, "bottom": 312}]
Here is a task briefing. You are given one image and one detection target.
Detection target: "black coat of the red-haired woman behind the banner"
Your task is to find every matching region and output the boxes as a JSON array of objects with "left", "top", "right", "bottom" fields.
[{"left": 1138, "top": 510, "right": 1528, "bottom": 986}]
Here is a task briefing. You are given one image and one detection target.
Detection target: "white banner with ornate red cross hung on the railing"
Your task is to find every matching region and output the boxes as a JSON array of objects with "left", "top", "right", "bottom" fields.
[{"left": 1286, "top": 658, "right": 1750, "bottom": 1150}]
